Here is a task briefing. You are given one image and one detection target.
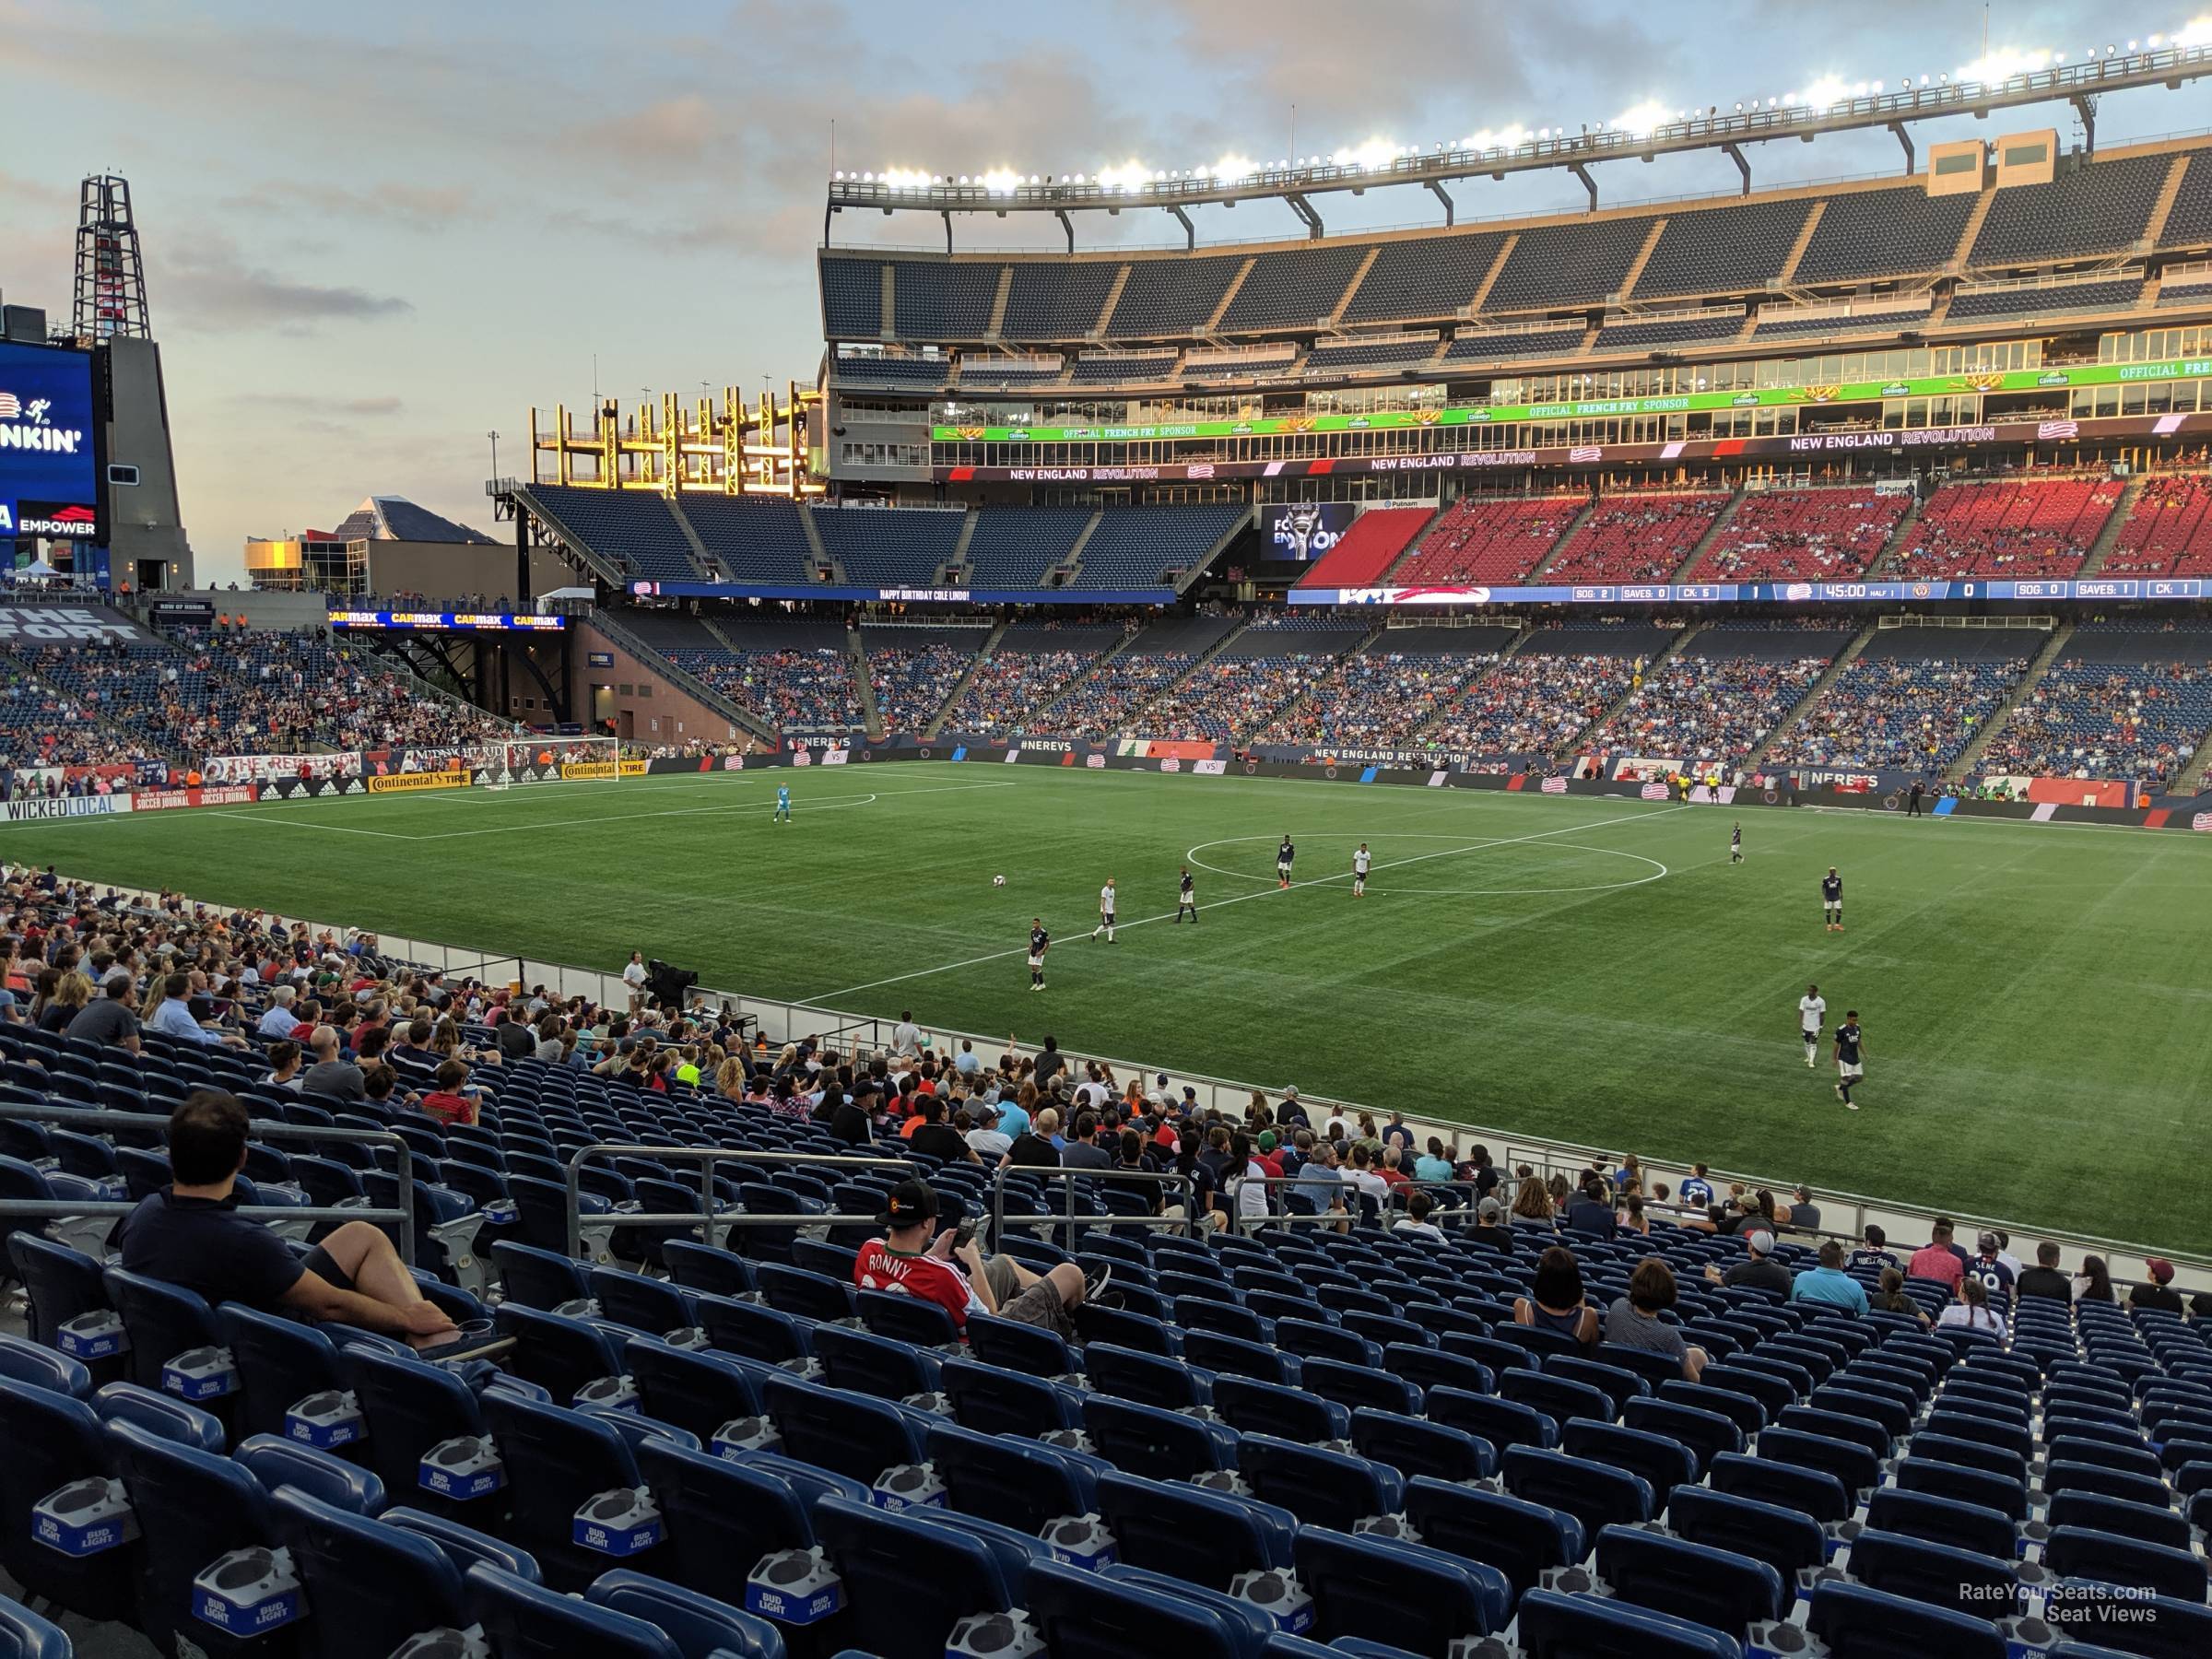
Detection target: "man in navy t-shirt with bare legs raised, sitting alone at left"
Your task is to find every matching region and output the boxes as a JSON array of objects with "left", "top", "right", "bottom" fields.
[{"left": 124, "top": 1088, "right": 455, "bottom": 1347}]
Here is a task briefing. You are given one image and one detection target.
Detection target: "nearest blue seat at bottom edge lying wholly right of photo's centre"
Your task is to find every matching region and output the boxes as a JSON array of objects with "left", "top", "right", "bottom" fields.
[{"left": 1292, "top": 1526, "right": 1513, "bottom": 1653}]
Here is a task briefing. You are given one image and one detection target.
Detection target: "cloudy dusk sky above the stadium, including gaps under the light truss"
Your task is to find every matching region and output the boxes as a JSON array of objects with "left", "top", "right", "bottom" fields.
[{"left": 0, "top": 0, "right": 2212, "bottom": 580}]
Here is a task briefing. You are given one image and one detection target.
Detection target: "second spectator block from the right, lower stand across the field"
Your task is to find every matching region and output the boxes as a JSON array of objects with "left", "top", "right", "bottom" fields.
[{"left": 1768, "top": 657, "right": 2029, "bottom": 772}]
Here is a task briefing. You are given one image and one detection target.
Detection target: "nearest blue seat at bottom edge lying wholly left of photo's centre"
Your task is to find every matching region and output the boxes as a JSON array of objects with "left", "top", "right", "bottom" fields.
[{"left": 814, "top": 1498, "right": 1029, "bottom": 1659}]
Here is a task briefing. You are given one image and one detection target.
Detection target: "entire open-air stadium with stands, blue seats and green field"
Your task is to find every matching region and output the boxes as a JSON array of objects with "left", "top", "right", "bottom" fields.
[{"left": 0, "top": 20, "right": 2212, "bottom": 1659}]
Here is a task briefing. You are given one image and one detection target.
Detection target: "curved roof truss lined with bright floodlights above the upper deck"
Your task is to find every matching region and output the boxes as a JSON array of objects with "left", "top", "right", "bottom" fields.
[{"left": 823, "top": 31, "right": 2212, "bottom": 253}]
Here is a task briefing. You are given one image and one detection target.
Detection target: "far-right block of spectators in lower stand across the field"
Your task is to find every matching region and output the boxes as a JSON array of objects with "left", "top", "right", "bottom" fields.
[{"left": 1982, "top": 662, "right": 2212, "bottom": 790}]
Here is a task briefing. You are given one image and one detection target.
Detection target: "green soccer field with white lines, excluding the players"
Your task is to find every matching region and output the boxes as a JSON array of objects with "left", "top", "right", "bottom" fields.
[{"left": 0, "top": 763, "right": 2212, "bottom": 1250}]
